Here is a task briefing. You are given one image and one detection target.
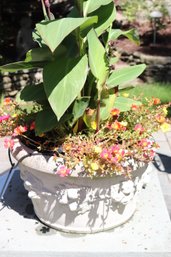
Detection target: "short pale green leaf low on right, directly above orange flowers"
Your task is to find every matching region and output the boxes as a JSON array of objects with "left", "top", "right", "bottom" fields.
[{"left": 114, "top": 96, "right": 142, "bottom": 112}]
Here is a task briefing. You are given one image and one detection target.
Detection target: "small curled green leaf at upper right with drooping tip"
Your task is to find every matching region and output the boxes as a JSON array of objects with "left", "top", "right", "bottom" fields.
[{"left": 108, "top": 29, "right": 140, "bottom": 45}]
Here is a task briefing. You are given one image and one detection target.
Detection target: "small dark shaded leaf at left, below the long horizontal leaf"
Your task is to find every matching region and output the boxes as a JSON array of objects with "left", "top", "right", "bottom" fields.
[{"left": 20, "top": 83, "right": 47, "bottom": 102}]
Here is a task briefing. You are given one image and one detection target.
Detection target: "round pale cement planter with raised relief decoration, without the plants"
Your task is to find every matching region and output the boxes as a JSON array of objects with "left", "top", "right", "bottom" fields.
[{"left": 12, "top": 137, "right": 148, "bottom": 233}]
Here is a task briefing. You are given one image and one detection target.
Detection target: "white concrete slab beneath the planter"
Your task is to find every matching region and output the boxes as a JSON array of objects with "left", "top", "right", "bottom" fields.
[{"left": 0, "top": 164, "right": 171, "bottom": 257}]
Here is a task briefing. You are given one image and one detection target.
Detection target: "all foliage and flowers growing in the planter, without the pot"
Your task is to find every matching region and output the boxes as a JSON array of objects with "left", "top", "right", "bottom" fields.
[{"left": 0, "top": 0, "right": 170, "bottom": 176}]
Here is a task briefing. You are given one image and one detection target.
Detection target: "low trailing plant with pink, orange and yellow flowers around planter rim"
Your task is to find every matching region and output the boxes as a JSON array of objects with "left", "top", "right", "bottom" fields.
[{"left": 0, "top": 95, "right": 169, "bottom": 177}]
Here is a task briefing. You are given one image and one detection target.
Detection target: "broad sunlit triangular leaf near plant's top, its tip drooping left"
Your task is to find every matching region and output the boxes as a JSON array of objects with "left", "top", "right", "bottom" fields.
[{"left": 36, "top": 17, "right": 97, "bottom": 52}]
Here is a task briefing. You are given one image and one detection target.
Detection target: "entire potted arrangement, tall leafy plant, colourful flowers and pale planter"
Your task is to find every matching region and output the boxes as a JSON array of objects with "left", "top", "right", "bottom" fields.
[{"left": 0, "top": 0, "right": 170, "bottom": 233}]
